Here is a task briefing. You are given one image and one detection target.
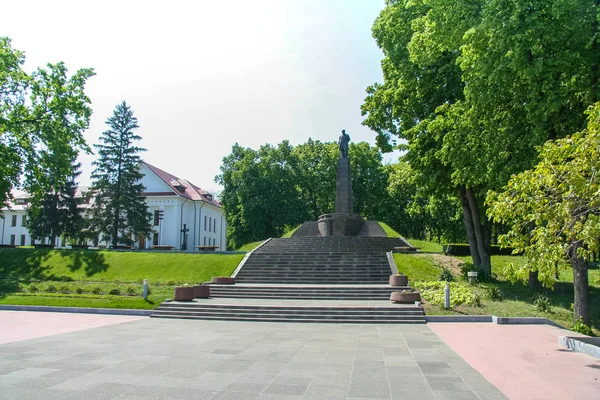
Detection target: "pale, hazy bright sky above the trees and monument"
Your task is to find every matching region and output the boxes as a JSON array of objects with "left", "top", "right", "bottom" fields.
[{"left": 0, "top": 0, "right": 397, "bottom": 192}]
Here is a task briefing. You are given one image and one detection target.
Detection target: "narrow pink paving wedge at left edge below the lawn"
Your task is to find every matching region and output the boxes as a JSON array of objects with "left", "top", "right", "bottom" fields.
[{"left": 0, "top": 310, "right": 147, "bottom": 344}]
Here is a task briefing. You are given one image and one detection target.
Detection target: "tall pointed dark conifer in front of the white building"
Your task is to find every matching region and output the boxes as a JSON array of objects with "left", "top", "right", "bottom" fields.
[{"left": 92, "top": 101, "right": 152, "bottom": 246}]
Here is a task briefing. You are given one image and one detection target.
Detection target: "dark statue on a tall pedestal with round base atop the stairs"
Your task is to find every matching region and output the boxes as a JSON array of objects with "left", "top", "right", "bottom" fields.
[{"left": 317, "top": 130, "right": 363, "bottom": 236}]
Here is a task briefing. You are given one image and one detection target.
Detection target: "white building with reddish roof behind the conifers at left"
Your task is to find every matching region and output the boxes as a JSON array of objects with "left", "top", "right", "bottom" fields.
[{"left": 0, "top": 162, "right": 227, "bottom": 251}]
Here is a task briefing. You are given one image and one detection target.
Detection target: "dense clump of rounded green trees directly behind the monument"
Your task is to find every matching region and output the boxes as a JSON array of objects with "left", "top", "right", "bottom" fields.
[{"left": 215, "top": 139, "right": 388, "bottom": 248}]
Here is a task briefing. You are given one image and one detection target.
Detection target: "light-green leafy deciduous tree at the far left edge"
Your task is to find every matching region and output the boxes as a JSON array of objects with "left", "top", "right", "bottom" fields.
[{"left": 0, "top": 37, "right": 94, "bottom": 206}]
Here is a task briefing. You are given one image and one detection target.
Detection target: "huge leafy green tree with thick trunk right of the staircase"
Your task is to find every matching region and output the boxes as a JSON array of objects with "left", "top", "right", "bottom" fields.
[{"left": 362, "top": 0, "right": 600, "bottom": 273}]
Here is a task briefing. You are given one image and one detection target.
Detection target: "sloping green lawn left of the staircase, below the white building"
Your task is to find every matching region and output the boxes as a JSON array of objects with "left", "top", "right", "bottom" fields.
[{"left": 0, "top": 249, "right": 244, "bottom": 308}]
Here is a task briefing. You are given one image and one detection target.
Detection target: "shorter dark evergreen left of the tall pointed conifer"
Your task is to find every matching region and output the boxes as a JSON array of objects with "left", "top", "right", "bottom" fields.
[{"left": 27, "top": 163, "right": 84, "bottom": 246}]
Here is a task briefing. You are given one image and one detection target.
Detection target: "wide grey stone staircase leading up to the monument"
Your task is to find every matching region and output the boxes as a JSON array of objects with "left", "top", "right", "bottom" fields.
[{"left": 152, "top": 236, "right": 425, "bottom": 323}]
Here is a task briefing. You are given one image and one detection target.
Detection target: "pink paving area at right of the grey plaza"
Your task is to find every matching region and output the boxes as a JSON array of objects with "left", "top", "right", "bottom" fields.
[{"left": 427, "top": 323, "right": 600, "bottom": 400}]
